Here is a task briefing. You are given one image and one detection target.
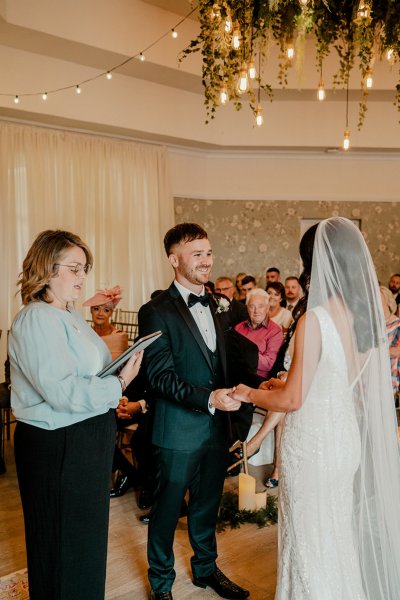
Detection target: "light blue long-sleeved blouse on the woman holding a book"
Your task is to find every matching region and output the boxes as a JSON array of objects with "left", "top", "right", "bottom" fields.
[{"left": 8, "top": 302, "right": 121, "bottom": 429}]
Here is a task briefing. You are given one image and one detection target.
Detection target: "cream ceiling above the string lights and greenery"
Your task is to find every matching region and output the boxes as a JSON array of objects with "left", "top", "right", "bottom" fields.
[{"left": 0, "top": 0, "right": 400, "bottom": 151}]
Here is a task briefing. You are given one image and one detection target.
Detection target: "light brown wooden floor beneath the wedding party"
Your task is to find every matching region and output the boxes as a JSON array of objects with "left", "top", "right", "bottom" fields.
[{"left": 0, "top": 428, "right": 277, "bottom": 600}]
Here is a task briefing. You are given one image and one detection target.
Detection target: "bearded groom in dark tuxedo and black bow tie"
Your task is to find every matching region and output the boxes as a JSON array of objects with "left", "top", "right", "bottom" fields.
[{"left": 139, "top": 223, "right": 249, "bottom": 600}]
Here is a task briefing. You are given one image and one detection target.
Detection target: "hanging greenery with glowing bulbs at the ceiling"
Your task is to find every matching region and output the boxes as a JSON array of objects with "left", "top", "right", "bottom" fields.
[{"left": 180, "top": 0, "right": 400, "bottom": 129}]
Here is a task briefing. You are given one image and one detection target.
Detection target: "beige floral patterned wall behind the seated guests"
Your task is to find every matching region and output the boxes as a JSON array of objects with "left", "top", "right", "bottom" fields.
[{"left": 175, "top": 198, "right": 400, "bottom": 286}]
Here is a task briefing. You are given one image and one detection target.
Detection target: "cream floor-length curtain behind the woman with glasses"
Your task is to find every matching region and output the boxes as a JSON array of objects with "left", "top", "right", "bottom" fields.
[{"left": 0, "top": 122, "right": 173, "bottom": 345}]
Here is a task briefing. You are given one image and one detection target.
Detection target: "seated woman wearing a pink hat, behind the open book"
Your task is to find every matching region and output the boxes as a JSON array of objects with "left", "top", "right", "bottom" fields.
[{"left": 83, "top": 285, "right": 128, "bottom": 360}]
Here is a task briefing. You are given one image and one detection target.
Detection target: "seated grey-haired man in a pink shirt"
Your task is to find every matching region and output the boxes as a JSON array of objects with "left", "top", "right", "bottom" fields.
[{"left": 235, "top": 288, "right": 283, "bottom": 379}]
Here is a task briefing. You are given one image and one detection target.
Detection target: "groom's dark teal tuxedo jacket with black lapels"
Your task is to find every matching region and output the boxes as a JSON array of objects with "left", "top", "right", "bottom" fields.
[{"left": 138, "top": 283, "right": 230, "bottom": 450}]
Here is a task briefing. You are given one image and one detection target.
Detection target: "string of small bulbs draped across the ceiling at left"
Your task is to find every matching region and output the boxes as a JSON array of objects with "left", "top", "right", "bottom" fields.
[{"left": 0, "top": 5, "right": 197, "bottom": 104}]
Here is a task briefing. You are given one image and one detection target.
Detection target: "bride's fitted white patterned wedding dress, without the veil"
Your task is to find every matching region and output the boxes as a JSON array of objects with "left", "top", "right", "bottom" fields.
[{"left": 275, "top": 306, "right": 366, "bottom": 600}]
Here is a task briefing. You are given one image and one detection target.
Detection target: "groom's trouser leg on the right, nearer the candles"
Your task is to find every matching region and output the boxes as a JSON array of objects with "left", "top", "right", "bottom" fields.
[{"left": 188, "top": 446, "right": 229, "bottom": 577}]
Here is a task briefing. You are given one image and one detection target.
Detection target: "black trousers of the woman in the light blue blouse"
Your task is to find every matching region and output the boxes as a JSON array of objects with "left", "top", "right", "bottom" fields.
[{"left": 14, "top": 410, "right": 116, "bottom": 600}]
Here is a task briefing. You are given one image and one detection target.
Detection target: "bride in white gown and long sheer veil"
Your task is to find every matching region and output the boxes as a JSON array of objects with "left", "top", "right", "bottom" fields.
[{"left": 235, "top": 217, "right": 400, "bottom": 600}]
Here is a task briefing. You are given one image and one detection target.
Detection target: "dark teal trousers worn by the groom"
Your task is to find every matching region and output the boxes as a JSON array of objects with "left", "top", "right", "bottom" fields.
[{"left": 147, "top": 445, "right": 228, "bottom": 592}]
